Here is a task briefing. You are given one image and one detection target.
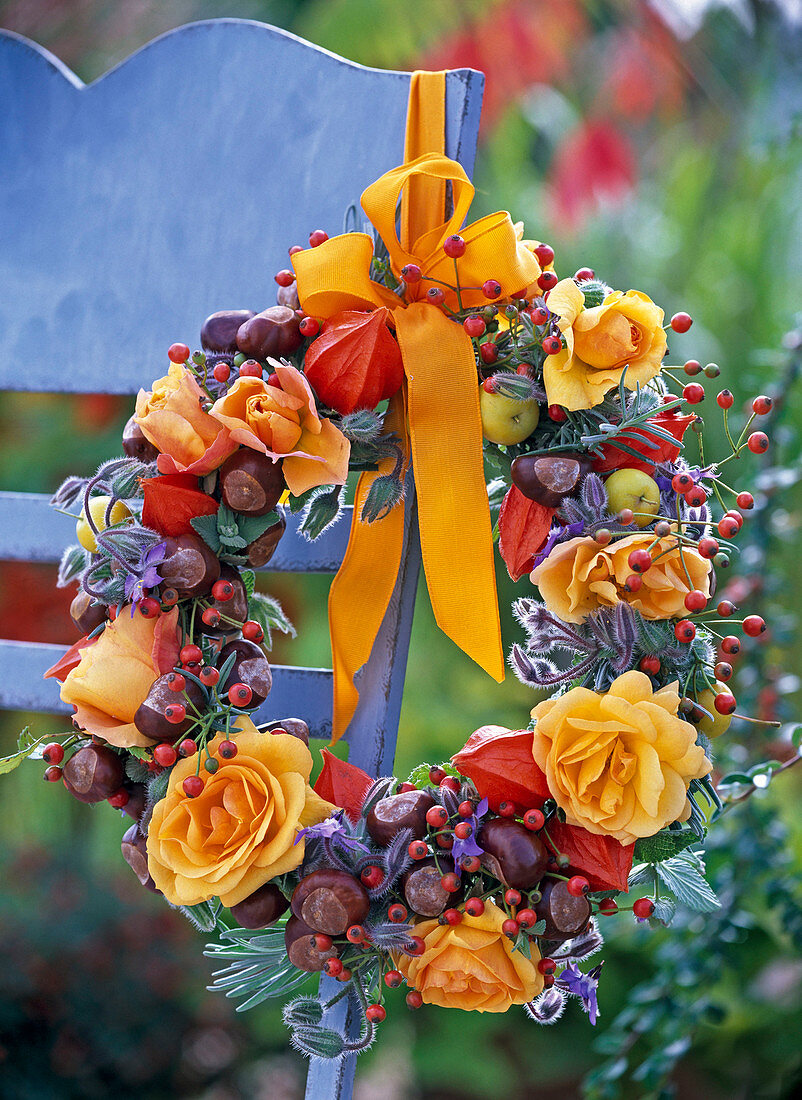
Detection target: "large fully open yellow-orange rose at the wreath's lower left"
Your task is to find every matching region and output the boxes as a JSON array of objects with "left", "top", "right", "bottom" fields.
[{"left": 147, "top": 716, "right": 334, "bottom": 906}]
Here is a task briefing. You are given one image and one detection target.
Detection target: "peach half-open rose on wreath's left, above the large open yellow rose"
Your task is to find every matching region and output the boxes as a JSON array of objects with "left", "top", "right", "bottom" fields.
[{"left": 62, "top": 607, "right": 178, "bottom": 748}]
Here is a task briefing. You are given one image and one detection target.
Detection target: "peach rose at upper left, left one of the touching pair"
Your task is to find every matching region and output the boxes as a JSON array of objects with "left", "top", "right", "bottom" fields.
[{"left": 135, "top": 363, "right": 237, "bottom": 477}]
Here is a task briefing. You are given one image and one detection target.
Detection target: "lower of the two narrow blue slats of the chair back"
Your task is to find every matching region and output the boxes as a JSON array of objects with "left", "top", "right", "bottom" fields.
[{"left": 0, "top": 640, "right": 331, "bottom": 738}]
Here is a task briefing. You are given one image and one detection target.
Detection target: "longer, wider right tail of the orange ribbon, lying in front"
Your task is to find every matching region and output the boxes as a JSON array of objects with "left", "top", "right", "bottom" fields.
[{"left": 396, "top": 303, "right": 505, "bottom": 683}]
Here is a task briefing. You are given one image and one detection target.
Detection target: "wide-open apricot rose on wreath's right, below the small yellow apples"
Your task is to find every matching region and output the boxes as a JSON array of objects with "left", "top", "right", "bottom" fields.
[{"left": 529, "top": 534, "right": 712, "bottom": 623}]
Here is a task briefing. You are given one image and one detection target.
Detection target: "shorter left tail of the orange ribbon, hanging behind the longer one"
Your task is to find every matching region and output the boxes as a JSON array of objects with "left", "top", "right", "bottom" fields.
[{"left": 329, "top": 392, "right": 408, "bottom": 745}]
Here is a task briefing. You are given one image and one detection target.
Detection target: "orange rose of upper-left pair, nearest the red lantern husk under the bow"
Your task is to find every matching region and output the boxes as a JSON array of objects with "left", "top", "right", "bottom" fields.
[{"left": 211, "top": 361, "right": 351, "bottom": 496}]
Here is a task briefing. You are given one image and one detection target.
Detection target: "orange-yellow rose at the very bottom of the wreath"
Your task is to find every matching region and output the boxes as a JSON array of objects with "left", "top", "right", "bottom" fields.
[{"left": 397, "top": 901, "right": 543, "bottom": 1012}]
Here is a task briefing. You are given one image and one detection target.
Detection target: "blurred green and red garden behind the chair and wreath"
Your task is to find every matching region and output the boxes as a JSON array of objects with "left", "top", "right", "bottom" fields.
[{"left": 0, "top": 0, "right": 802, "bottom": 1100}]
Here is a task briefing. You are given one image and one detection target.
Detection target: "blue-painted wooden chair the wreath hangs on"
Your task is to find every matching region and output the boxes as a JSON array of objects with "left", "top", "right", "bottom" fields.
[{"left": 0, "top": 20, "right": 483, "bottom": 1100}]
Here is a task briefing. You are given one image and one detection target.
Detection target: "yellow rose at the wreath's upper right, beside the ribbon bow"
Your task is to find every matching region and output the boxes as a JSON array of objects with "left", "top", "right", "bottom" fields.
[{"left": 543, "top": 278, "right": 667, "bottom": 409}]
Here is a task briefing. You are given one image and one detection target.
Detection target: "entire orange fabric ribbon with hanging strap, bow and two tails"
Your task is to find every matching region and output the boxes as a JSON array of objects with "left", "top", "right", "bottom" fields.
[{"left": 293, "top": 73, "right": 540, "bottom": 741}]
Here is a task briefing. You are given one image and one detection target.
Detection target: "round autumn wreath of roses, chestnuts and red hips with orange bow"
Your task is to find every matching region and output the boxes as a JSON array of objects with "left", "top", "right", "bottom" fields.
[{"left": 0, "top": 73, "right": 792, "bottom": 1057}]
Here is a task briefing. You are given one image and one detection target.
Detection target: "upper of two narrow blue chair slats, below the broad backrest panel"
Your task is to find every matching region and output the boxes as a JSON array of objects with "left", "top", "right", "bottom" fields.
[{"left": 0, "top": 492, "right": 352, "bottom": 573}]
